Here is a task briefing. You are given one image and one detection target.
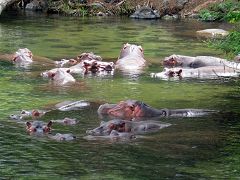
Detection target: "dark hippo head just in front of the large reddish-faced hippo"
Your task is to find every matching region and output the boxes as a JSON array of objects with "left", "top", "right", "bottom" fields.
[{"left": 87, "top": 119, "right": 131, "bottom": 136}]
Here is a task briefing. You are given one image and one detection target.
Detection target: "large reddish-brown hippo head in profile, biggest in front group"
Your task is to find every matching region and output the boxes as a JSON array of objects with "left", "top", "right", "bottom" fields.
[{"left": 98, "top": 100, "right": 159, "bottom": 119}]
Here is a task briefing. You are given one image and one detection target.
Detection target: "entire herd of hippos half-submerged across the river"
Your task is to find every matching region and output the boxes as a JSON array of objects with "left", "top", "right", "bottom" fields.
[{"left": 4, "top": 43, "right": 240, "bottom": 141}]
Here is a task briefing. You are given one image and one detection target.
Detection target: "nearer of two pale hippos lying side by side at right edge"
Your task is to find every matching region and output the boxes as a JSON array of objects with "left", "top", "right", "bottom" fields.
[{"left": 151, "top": 66, "right": 240, "bottom": 80}]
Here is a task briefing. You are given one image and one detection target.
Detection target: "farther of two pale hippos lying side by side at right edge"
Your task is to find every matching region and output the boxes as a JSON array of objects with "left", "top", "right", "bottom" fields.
[{"left": 163, "top": 54, "right": 240, "bottom": 70}]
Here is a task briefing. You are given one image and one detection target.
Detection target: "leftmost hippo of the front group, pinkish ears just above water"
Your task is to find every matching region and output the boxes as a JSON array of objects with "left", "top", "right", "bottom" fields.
[{"left": 9, "top": 109, "right": 47, "bottom": 120}]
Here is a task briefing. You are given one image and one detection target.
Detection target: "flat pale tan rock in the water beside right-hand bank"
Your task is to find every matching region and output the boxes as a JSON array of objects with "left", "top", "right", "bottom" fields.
[{"left": 196, "top": 29, "right": 228, "bottom": 38}]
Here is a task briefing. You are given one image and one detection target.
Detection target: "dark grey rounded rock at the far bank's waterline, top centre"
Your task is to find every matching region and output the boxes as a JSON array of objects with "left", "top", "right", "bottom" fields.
[{"left": 130, "top": 7, "right": 160, "bottom": 19}]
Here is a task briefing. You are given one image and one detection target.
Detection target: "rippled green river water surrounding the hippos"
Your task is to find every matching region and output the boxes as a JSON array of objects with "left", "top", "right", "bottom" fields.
[{"left": 0, "top": 12, "right": 240, "bottom": 180}]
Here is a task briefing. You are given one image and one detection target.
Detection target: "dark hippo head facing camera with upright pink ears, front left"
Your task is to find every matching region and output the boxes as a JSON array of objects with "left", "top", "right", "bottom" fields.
[{"left": 26, "top": 121, "right": 52, "bottom": 134}]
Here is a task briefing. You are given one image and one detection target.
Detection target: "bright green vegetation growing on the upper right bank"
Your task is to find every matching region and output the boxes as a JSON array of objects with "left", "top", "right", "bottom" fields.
[{"left": 200, "top": 0, "right": 240, "bottom": 58}]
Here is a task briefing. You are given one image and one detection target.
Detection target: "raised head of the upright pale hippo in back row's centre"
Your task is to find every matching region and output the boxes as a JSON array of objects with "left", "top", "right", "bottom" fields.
[{"left": 119, "top": 43, "right": 144, "bottom": 59}]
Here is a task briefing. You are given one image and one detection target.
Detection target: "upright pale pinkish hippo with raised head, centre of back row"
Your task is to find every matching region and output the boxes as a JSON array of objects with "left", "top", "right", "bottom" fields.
[{"left": 116, "top": 43, "right": 146, "bottom": 74}]
